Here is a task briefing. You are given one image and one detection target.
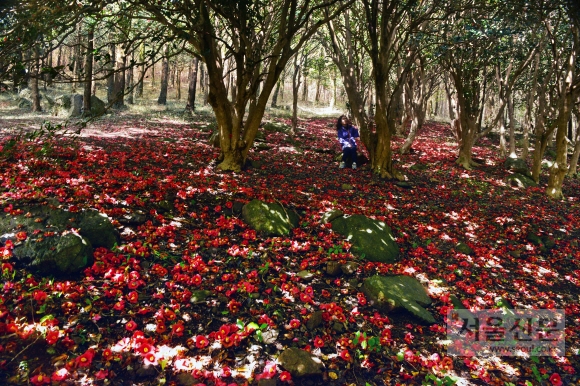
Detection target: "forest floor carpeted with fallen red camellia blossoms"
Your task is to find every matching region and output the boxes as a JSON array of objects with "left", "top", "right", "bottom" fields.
[{"left": 0, "top": 94, "right": 580, "bottom": 385}]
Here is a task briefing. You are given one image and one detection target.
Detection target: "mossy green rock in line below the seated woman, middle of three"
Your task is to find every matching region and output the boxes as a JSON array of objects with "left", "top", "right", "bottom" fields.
[{"left": 331, "top": 215, "right": 399, "bottom": 263}]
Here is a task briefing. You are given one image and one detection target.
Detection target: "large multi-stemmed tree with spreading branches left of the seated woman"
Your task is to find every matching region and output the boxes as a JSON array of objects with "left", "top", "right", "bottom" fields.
[{"left": 120, "top": 0, "right": 353, "bottom": 171}]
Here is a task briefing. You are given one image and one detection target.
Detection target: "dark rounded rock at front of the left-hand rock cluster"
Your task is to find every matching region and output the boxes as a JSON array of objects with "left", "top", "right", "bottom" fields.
[{"left": 13, "top": 233, "right": 93, "bottom": 275}]
